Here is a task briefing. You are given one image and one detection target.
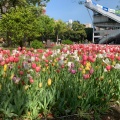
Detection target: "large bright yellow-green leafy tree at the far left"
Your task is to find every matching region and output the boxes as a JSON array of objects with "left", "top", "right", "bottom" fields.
[{"left": 0, "top": 7, "right": 38, "bottom": 47}]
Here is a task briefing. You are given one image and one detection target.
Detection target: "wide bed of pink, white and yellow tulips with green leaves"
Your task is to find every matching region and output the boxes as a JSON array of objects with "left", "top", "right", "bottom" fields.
[{"left": 0, "top": 44, "right": 120, "bottom": 119}]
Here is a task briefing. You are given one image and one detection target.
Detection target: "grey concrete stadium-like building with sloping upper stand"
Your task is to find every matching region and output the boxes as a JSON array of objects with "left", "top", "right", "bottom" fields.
[{"left": 85, "top": 0, "right": 120, "bottom": 44}]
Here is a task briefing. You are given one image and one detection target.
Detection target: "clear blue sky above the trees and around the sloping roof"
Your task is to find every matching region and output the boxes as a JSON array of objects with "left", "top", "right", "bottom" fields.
[{"left": 46, "top": 0, "right": 120, "bottom": 24}]
